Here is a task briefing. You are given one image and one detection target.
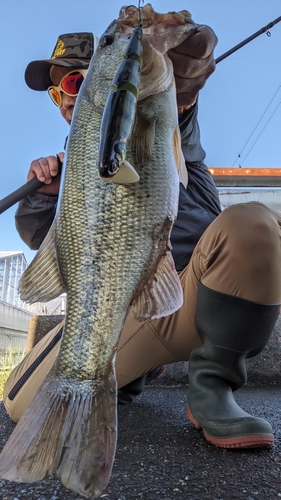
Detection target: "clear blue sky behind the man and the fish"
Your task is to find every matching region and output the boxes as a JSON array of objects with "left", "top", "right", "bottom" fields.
[{"left": 0, "top": 0, "right": 281, "bottom": 262}]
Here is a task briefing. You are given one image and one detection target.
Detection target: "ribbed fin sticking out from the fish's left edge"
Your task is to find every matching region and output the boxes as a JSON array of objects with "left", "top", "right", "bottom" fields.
[{"left": 19, "top": 229, "right": 66, "bottom": 304}]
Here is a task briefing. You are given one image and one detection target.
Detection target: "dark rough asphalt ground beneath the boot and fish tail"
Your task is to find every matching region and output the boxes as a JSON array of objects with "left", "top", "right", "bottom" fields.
[{"left": 0, "top": 380, "right": 281, "bottom": 500}]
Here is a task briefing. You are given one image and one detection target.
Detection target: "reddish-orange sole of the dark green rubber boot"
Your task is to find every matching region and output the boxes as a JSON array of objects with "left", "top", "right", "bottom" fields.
[{"left": 186, "top": 407, "right": 274, "bottom": 448}]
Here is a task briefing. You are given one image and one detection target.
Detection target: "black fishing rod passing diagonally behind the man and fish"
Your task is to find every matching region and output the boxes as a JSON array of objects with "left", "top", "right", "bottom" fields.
[{"left": 0, "top": 16, "right": 281, "bottom": 214}]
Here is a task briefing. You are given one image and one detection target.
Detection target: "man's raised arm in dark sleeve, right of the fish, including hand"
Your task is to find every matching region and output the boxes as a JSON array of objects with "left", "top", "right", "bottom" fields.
[{"left": 169, "top": 26, "right": 221, "bottom": 271}]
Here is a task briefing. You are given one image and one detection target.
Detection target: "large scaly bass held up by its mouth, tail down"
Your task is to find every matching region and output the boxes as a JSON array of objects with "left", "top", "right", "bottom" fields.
[{"left": 0, "top": 4, "right": 196, "bottom": 498}]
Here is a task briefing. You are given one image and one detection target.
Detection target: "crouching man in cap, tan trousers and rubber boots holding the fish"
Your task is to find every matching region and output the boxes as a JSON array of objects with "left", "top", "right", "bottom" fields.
[{"left": 4, "top": 5, "right": 281, "bottom": 464}]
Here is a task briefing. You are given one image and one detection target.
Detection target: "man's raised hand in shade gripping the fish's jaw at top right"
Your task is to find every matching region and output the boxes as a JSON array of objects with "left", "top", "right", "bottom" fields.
[{"left": 168, "top": 25, "right": 218, "bottom": 113}]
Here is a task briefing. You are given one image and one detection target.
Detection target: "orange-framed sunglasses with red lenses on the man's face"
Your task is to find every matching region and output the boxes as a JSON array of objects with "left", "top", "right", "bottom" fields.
[{"left": 47, "top": 69, "right": 87, "bottom": 108}]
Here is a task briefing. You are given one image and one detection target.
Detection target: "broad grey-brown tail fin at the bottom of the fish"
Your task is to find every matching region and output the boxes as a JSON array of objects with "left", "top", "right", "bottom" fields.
[{"left": 0, "top": 372, "right": 117, "bottom": 498}]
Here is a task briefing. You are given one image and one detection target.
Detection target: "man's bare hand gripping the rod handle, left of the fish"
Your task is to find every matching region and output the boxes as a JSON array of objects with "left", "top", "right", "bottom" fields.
[{"left": 27, "top": 152, "right": 64, "bottom": 196}]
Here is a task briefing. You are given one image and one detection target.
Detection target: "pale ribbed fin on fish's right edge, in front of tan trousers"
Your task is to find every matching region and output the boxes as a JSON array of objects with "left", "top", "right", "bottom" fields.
[{"left": 132, "top": 251, "right": 183, "bottom": 321}]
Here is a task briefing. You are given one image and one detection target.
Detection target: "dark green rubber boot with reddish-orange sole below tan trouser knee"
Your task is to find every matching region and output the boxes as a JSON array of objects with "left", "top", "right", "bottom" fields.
[{"left": 187, "top": 283, "right": 280, "bottom": 448}]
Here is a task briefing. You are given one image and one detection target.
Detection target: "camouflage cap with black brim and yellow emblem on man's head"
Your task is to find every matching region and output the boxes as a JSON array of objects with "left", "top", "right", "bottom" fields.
[{"left": 24, "top": 33, "right": 98, "bottom": 90}]
